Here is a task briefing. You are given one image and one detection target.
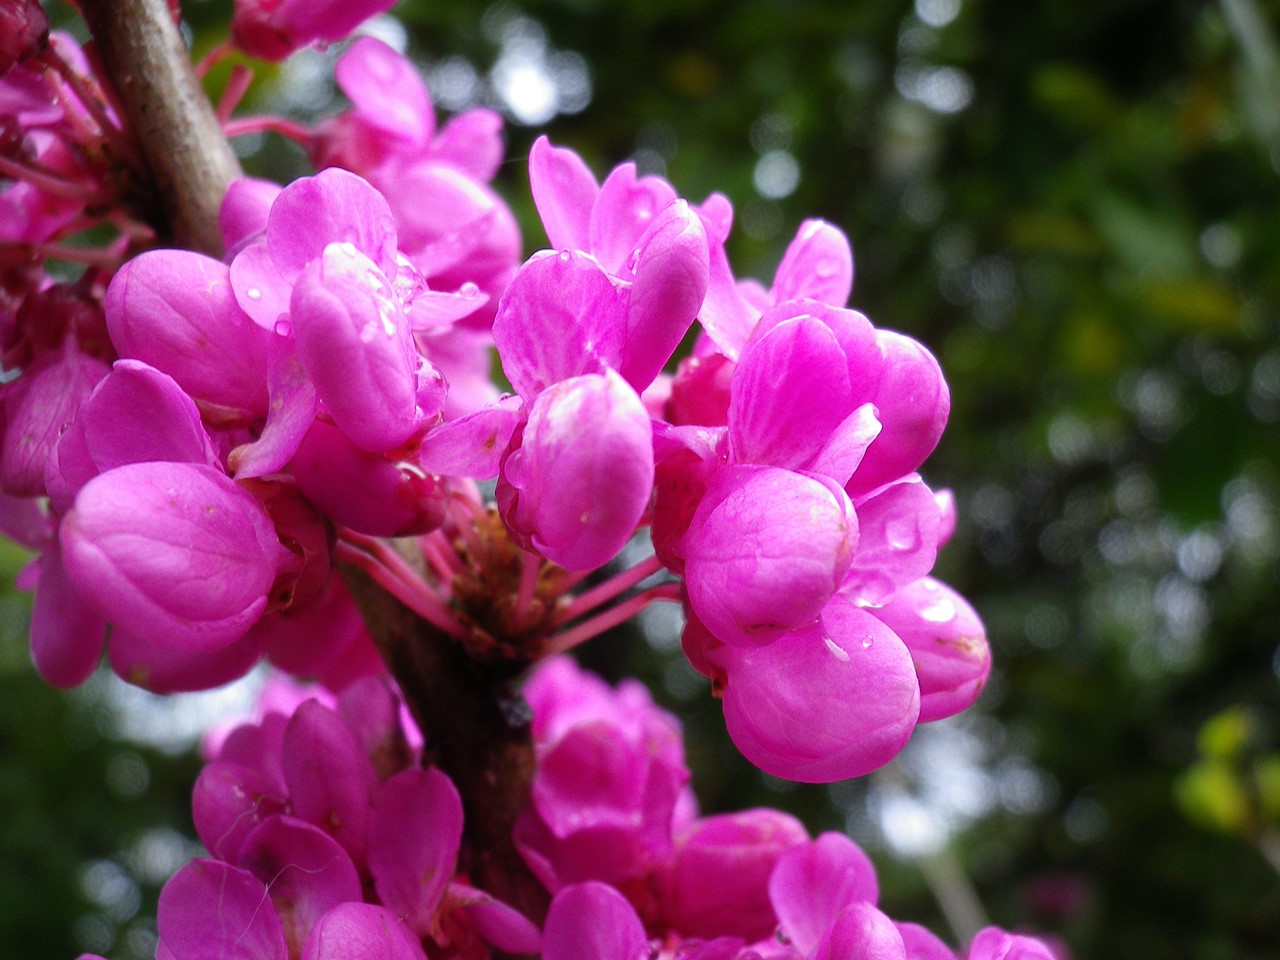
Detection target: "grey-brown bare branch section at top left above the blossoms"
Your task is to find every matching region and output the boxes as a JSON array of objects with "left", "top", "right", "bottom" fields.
[{"left": 79, "top": 0, "right": 241, "bottom": 256}]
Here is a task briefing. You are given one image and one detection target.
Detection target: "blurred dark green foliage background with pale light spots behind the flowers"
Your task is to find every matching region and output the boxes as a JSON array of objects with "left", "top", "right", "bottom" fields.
[{"left": 10, "top": 0, "right": 1280, "bottom": 960}]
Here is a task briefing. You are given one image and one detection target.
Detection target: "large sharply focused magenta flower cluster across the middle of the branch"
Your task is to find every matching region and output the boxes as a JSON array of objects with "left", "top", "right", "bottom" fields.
[{"left": 0, "top": 24, "right": 989, "bottom": 781}]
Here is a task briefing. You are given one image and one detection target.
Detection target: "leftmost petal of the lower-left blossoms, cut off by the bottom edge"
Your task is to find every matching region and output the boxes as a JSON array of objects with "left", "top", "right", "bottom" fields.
[{"left": 156, "top": 860, "right": 288, "bottom": 960}]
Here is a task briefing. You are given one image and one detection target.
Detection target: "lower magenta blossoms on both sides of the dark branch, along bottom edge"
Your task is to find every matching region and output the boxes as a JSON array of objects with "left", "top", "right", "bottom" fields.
[{"left": 124, "top": 658, "right": 1053, "bottom": 960}]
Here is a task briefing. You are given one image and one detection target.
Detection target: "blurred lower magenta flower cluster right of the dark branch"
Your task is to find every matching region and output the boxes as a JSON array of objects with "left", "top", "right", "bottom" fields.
[{"left": 517, "top": 660, "right": 1055, "bottom": 960}]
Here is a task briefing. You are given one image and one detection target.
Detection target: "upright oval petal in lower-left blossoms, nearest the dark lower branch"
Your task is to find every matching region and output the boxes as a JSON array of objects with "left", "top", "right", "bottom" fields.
[{"left": 369, "top": 768, "right": 462, "bottom": 937}]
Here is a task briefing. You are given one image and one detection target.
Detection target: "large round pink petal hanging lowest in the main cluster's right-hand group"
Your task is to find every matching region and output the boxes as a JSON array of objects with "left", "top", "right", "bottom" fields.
[{"left": 717, "top": 596, "right": 920, "bottom": 783}]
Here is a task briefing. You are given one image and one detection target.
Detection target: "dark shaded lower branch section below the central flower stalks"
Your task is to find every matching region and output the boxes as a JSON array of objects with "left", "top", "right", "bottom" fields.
[{"left": 343, "top": 567, "right": 548, "bottom": 942}]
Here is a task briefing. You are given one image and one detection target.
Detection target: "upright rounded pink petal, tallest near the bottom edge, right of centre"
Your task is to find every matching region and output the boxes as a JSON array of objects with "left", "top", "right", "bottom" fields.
[{"left": 769, "top": 833, "right": 879, "bottom": 955}]
